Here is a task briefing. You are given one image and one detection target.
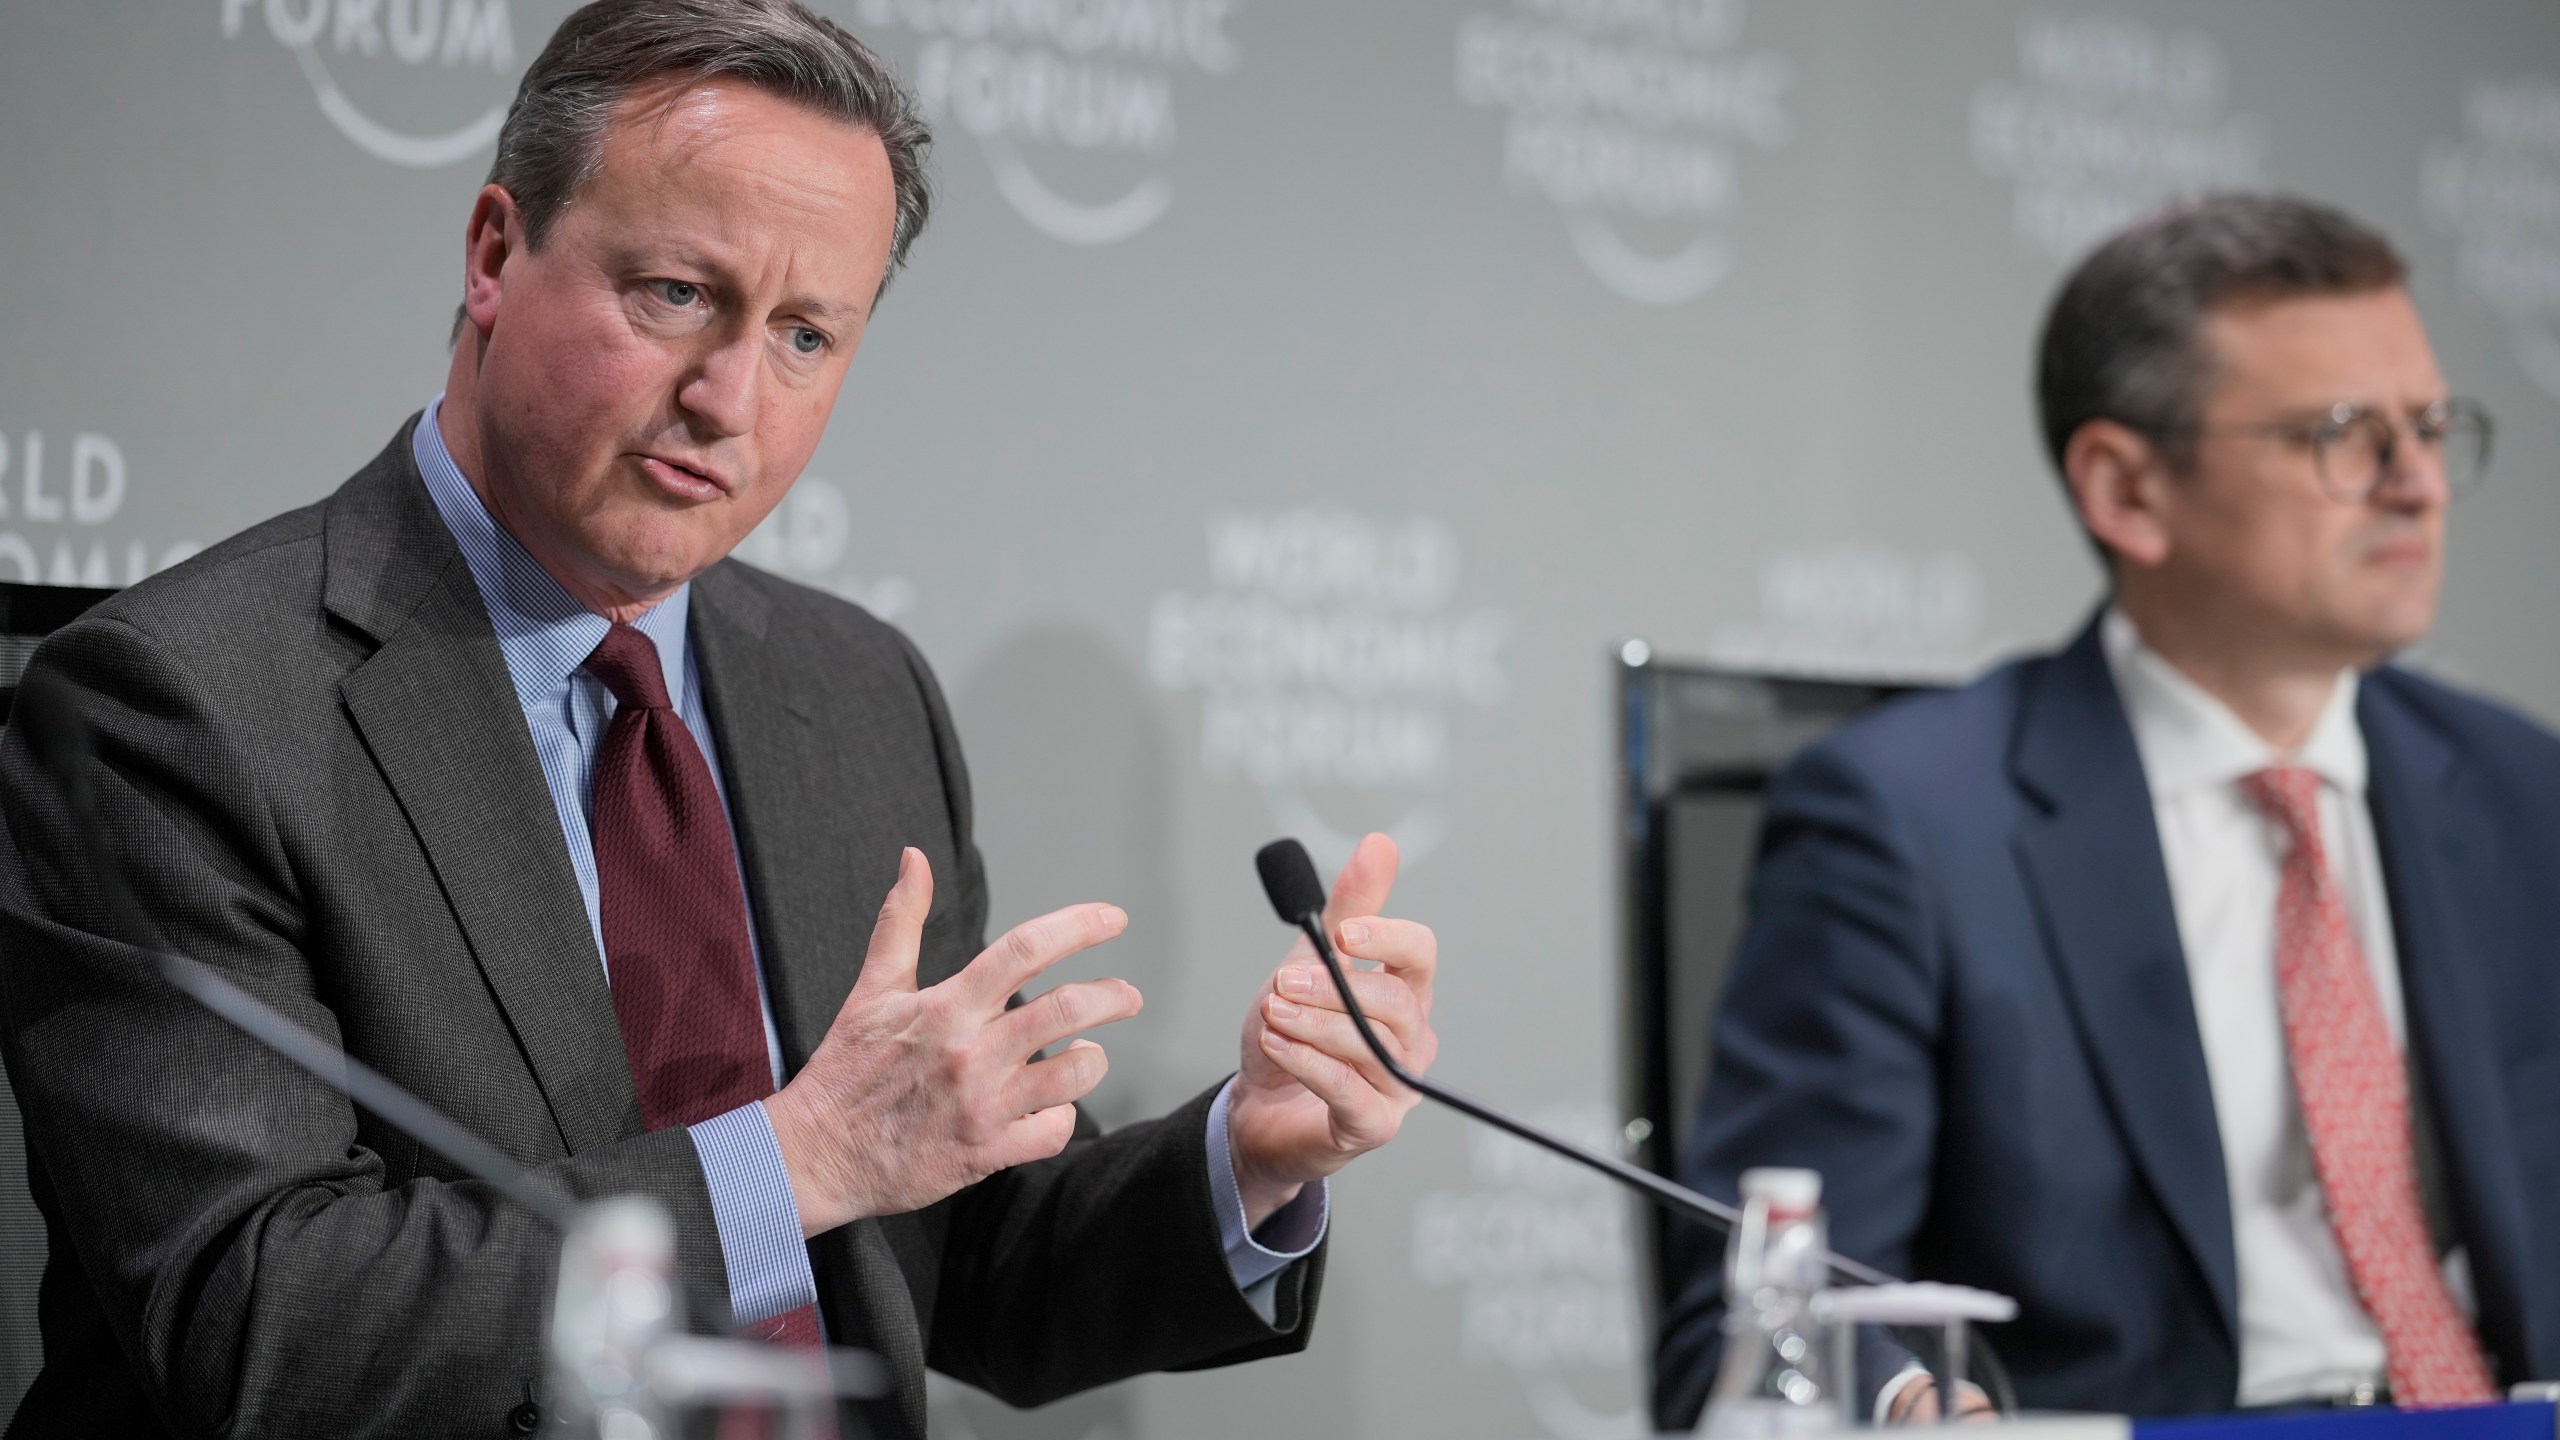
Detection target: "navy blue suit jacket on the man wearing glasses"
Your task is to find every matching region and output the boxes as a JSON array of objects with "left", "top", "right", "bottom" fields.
[{"left": 1656, "top": 609, "right": 2560, "bottom": 1425}]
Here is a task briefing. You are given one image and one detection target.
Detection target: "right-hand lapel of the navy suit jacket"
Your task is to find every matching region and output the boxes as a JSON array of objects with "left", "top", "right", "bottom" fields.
[{"left": 2355, "top": 671, "right": 2532, "bottom": 1368}]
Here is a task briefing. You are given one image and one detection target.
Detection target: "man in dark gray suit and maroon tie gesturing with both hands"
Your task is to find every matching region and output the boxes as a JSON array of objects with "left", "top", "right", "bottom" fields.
[{"left": 0, "top": 0, "right": 1436, "bottom": 1435}]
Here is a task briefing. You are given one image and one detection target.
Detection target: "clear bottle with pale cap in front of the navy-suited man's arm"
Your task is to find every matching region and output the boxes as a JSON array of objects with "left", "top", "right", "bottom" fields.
[{"left": 1697, "top": 1168, "right": 1841, "bottom": 1440}]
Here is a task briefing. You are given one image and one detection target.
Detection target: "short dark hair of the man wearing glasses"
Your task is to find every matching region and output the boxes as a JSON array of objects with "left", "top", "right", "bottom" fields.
[{"left": 2035, "top": 195, "right": 2409, "bottom": 474}]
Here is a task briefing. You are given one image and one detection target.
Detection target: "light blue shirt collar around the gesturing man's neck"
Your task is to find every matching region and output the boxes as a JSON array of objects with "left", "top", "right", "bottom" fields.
[{"left": 410, "top": 395, "right": 694, "bottom": 707}]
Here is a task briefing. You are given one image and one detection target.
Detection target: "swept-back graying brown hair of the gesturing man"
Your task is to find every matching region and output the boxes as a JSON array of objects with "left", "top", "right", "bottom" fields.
[{"left": 453, "top": 0, "right": 934, "bottom": 336}]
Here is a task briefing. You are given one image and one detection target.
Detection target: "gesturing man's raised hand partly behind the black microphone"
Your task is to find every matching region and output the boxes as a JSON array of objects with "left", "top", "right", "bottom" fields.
[{"left": 1226, "top": 835, "right": 1439, "bottom": 1227}]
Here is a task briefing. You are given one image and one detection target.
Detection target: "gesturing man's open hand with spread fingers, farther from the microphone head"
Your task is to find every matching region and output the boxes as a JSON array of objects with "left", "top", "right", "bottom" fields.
[{"left": 765, "top": 848, "right": 1144, "bottom": 1238}]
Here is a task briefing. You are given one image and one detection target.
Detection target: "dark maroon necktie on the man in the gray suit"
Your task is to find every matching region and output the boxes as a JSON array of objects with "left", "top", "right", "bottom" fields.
[{"left": 586, "top": 625, "right": 819, "bottom": 1345}]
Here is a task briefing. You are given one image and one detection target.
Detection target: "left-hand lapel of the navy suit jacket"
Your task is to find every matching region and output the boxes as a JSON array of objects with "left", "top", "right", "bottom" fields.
[{"left": 2012, "top": 625, "right": 2240, "bottom": 1343}]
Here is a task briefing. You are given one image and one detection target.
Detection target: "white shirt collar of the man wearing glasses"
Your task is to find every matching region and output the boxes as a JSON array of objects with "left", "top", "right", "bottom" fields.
[{"left": 2099, "top": 605, "right": 2365, "bottom": 799}]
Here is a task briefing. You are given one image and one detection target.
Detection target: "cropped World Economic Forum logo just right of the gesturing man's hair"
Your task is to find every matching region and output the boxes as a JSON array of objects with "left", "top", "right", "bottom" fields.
[{"left": 837, "top": 0, "right": 1244, "bottom": 246}]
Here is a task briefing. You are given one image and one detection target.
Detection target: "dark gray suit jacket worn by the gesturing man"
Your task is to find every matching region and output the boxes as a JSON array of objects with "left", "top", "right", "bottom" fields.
[{"left": 0, "top": 418, "right": 1324, "bottom": 1435}]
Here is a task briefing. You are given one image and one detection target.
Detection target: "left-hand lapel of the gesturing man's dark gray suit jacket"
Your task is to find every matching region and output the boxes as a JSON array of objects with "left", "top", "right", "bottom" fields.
[{"left": 325, "top": 428, "right": 640, "bottom": 1150}]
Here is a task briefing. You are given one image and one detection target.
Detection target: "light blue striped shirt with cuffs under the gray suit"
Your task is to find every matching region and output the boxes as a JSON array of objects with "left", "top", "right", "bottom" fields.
[{"left": 410, "top": 395, "right": 1329, "bottom": 1325}]
